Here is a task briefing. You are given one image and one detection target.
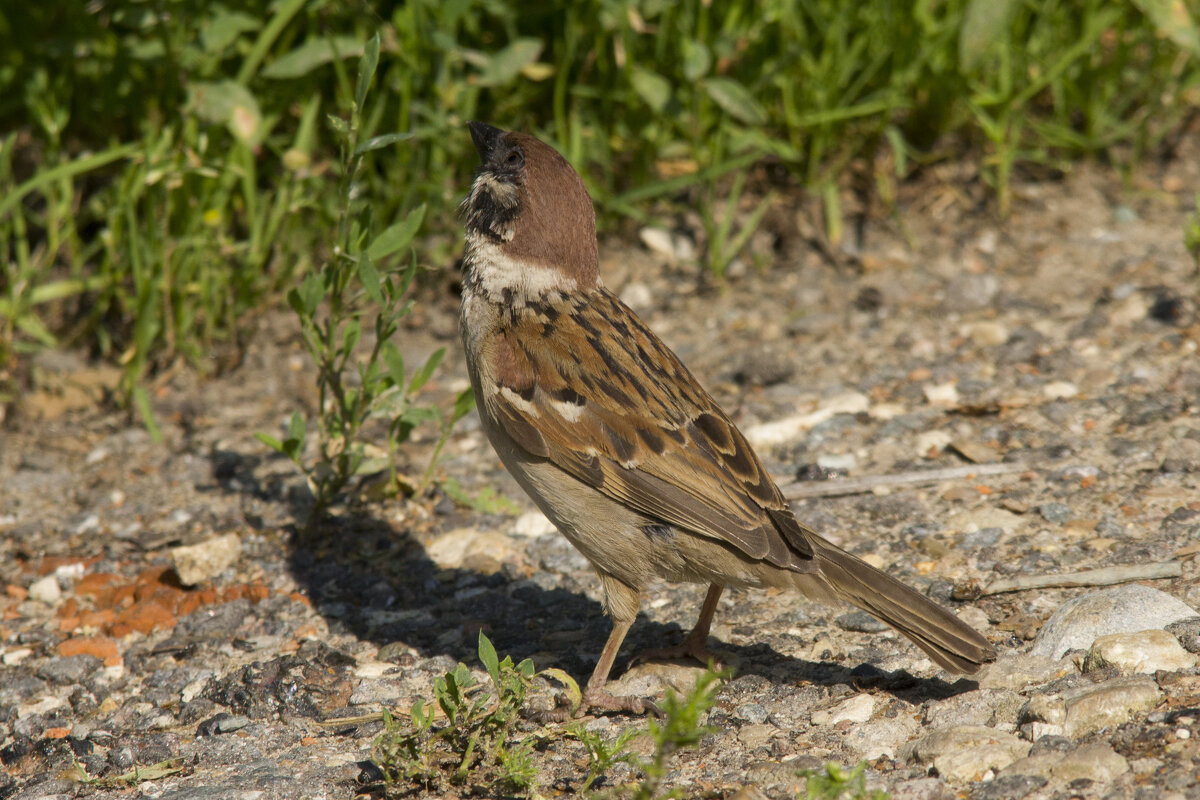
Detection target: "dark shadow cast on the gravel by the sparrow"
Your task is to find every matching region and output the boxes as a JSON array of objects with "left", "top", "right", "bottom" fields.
[{"left": 212, "top": 451, "right": 977, "bottom": 703}]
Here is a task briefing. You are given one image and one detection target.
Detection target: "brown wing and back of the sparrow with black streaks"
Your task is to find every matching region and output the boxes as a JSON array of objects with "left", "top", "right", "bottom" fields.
[{"left": 481, "top": 289, "right": 812, "bottom": 571}]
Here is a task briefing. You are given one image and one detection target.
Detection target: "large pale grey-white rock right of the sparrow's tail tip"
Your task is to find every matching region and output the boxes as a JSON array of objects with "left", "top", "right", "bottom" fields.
[{"left": 1030, "top": 583, "right": 1200, "bottom": 658}]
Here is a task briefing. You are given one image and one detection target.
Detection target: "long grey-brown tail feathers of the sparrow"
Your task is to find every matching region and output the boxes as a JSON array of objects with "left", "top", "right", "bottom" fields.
[{"left": 808, "top": 536, "right": 996, "bottom": 674}]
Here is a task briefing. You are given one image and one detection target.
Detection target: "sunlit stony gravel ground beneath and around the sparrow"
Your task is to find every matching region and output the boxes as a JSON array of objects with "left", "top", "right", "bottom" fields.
[{"left": 7, "top": 146, "right": 1200, "bottom": 800}]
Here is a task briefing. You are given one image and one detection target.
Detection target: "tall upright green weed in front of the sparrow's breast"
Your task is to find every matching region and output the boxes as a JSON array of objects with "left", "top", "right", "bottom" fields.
[{"left": 258, "top": 36, "right": 474, "bottom": 523}]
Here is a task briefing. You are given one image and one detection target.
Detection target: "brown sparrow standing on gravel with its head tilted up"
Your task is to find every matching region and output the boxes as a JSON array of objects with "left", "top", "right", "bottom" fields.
[{"left": 461, "top": 121, "right": 996, "bottom": 718}]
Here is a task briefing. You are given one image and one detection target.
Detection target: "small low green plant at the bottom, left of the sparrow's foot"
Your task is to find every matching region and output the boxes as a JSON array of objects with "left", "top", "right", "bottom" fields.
[{"left": 372, "top": 631, "right": 554, "bottom": 793}]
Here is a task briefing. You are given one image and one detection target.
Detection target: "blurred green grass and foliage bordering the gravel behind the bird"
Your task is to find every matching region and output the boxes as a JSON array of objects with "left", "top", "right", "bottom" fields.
[{"left": 0, "top": 0, "right": 1200, "bottom": 402}]
